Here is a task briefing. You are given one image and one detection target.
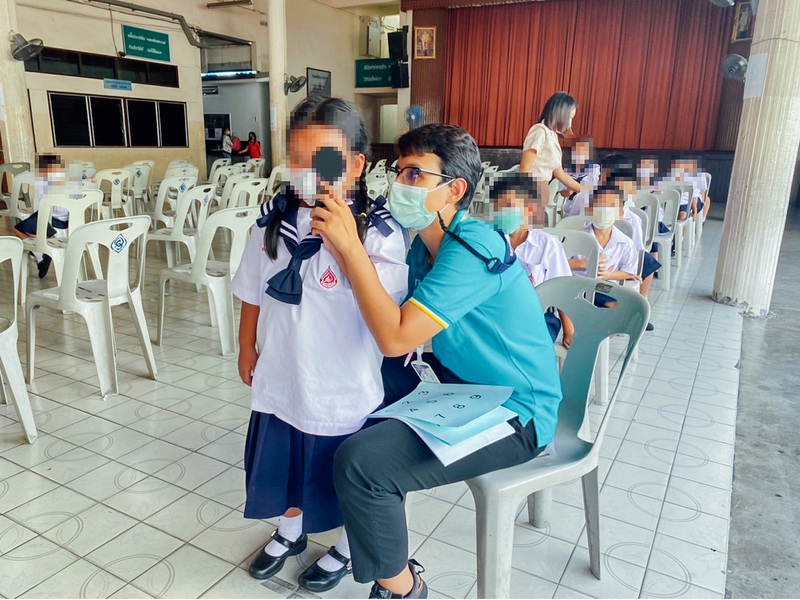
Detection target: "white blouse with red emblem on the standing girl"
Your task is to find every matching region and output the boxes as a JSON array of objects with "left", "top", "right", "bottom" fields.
[{"left": 231, "top": 208, "right": 408, "bottom": 436}]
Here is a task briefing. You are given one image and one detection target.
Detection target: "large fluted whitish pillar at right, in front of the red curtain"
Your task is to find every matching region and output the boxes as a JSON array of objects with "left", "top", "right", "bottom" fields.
[{"left": 713, "top": 0, "right": 800, "bottom": 316}]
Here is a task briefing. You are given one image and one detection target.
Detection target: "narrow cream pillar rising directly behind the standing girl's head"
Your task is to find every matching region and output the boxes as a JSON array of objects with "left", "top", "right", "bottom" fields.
[{"left": 267, "top": 0, "right": 289, "bottom": 166}]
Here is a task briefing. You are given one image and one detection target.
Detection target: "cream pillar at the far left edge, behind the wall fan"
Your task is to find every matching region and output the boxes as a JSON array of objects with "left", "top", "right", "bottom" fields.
[{"left": 0, "top": 0, "right": 35, "bottom": 164}]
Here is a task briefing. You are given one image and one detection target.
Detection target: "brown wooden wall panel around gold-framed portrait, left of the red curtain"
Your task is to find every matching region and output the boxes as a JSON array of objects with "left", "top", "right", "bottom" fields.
[{"left": 409, "top": 8, "right": 448, "bottom": 123}]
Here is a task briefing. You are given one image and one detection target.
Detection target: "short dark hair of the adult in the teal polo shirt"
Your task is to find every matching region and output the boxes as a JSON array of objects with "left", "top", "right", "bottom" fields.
[{"left": 396, "top": 123, "right": 483, "bottom": 210}]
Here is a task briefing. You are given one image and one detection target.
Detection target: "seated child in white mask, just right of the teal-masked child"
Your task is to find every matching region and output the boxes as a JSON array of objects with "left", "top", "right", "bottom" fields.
[{"left": 569, "top": 185, "right": 642, "bottom": 308}]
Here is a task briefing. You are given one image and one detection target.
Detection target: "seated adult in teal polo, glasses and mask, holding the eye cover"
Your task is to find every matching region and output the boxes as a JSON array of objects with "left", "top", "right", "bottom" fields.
[{"left": 312, "top": 125, "right": 561, "bottom": 598}]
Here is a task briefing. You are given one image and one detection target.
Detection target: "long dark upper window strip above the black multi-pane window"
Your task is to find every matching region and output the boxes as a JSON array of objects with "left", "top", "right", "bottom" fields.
[{"left": 25, "top": 48, "right": 179, "bottom": 87}]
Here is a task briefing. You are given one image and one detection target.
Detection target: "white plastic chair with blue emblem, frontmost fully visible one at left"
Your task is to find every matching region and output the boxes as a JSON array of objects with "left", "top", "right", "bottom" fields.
[{"left": 27, "top": 215, "right": 158, "bottom": 398}]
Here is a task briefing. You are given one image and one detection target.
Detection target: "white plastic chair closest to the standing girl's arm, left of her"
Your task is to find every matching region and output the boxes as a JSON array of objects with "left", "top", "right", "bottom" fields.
[{"left": 156, "top": 206, "right": 261, "bottom": 356}]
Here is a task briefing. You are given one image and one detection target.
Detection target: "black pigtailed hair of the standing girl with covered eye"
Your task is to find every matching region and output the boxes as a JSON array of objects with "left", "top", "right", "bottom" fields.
[{"left": 264, "top": 95, "right": 370, "bottom": 260}]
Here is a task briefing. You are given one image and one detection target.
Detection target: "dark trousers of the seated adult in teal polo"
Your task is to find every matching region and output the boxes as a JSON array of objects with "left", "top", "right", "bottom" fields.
[{"left": 333, "top": 356, "right": 543, "bottom": 583}]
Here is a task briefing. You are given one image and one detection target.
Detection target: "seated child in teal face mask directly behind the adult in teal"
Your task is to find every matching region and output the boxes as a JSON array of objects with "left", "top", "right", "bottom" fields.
[{"left": 489, "top": 173, "right": 575, "bottom": 348}]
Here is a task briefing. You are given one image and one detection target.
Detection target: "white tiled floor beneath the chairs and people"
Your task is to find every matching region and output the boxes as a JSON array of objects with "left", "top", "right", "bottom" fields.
[{"left": 0, "top": 221, "right": 742, "bottom": 598}]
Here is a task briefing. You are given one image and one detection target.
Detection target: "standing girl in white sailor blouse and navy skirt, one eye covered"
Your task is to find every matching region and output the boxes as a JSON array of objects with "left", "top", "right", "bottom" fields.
[{"left": 231, "top": 97, "right": 408, "bottom": 592}]
